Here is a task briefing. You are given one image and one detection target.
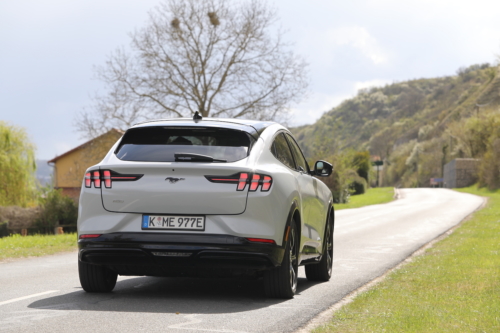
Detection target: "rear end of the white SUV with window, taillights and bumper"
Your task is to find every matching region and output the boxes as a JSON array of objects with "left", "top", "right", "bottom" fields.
[{"left": 78, "top": 120, "right": 287, "bottom": 276}]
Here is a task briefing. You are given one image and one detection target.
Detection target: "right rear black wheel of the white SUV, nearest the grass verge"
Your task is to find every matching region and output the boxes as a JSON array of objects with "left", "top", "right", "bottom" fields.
[{"left": 264, "top": 221, "right": 299, "bottom": 298}]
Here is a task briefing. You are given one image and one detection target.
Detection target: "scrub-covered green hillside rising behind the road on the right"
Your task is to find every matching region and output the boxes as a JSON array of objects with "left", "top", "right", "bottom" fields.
[{"left": 292, "top": 64, "right": 500, "bottom": 186}]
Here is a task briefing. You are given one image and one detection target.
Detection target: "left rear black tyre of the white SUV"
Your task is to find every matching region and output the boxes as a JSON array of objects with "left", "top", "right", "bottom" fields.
[{"left": 78, "top": 261, "right": 118, "bottom": 293}]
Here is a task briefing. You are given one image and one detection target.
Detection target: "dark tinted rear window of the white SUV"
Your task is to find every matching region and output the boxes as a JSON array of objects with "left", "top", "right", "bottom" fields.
[{"left": 115, "top": 126, "right": 254, "bottom": 162}]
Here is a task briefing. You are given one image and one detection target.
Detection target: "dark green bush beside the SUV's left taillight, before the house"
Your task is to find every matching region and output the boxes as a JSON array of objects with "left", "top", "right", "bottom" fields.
[{"left": 35, "top": 188, "right": 78, "bottom": 230}]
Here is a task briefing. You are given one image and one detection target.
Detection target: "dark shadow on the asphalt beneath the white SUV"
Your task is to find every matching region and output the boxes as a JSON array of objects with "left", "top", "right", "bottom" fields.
[{"left": 28, "top": 277, "right": 316, "bottom": 314}]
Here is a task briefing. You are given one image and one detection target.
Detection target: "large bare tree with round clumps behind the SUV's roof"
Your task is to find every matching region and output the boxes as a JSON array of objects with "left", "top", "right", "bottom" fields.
[{"left": 76, "top": 0, "right": 307, "bottom": 137}]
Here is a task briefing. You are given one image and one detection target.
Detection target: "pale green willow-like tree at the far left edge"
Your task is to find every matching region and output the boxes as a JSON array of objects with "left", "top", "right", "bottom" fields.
[{"left": 0, "top": 121, "right": 36, "bottom": 207}]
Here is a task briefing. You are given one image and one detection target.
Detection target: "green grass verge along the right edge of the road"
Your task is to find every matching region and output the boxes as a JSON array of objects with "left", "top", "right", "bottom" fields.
[{"left": 313, "top": 187, "right": 500, "bottom": 333}]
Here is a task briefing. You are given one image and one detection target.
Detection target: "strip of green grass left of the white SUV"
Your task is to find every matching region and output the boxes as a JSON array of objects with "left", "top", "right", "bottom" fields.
[{"left": 0, "top": 233, "right": 77, "bottom": 260}]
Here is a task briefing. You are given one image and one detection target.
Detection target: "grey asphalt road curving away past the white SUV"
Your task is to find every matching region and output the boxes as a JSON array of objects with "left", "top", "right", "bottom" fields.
[{"left": 0, "top": 189, "right": 483, "bottom": 332}]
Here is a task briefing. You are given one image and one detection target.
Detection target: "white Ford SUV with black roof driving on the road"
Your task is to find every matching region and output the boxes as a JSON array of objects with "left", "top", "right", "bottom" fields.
[{"left": 78, "top": 118, "right": 334, "bottom": 298}]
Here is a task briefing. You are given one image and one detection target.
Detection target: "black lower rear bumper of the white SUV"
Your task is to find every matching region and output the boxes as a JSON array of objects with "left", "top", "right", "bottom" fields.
[{"left": 78, "top": 232, "right": 284, "bottom": 276}]
